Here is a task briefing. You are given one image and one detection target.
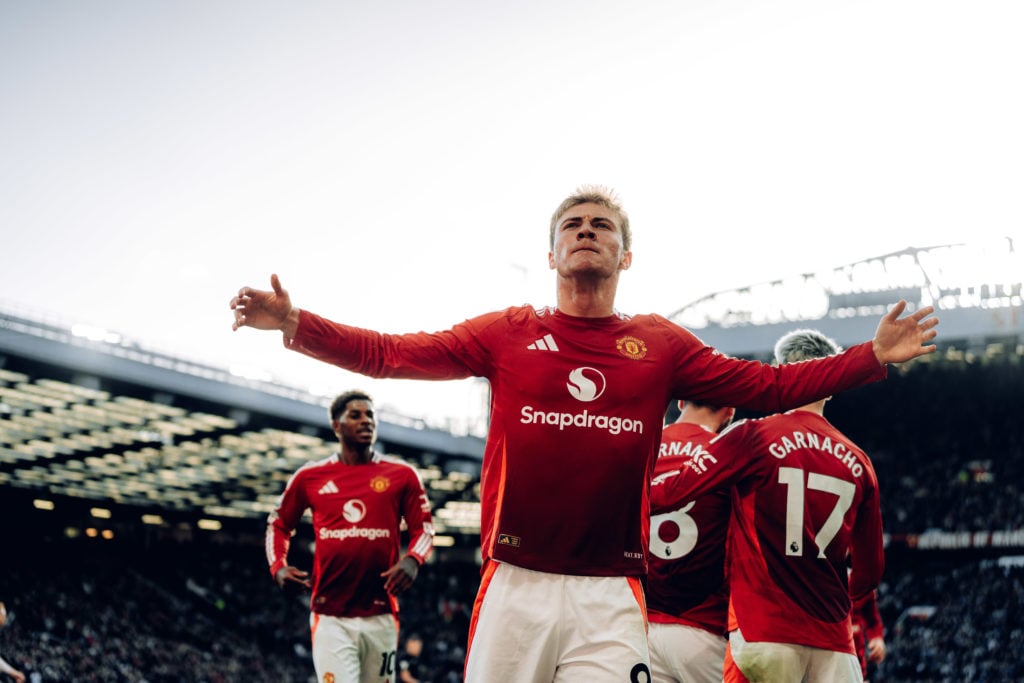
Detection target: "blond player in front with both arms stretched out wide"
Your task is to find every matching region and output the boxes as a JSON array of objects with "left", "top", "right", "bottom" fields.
[{"left": 230, "top": 187, "right": 937, "bottom": 683}]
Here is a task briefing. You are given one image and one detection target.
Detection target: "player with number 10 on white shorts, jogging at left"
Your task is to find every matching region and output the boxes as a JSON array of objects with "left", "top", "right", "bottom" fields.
[{"left": 266, "top": 391, "right": 433, "bottom": 683}]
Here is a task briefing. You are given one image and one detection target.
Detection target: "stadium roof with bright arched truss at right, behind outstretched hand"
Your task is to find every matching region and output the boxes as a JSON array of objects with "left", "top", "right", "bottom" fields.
[{"left": 669, "top": 238, "right": 1024, "bottom": 358}]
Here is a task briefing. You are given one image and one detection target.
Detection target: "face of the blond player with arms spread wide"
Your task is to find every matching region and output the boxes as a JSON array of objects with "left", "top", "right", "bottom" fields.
[{"left": 548, "top": 204, "right": 633, "bottom": 278}]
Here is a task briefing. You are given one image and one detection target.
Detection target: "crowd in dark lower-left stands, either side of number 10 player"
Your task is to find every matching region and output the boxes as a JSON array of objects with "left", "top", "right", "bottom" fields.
[{"left": 0, "top": 541, "right": 478, "bottom": 683}]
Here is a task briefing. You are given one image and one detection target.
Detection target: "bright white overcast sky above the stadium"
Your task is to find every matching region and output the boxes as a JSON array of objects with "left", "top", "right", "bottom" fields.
[{"left": 0, "top": 0, "right": 1024, "bottom": 436}]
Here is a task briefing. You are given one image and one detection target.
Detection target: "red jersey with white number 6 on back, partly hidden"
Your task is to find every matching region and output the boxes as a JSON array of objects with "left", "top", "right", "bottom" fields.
[{"left": 646, "top": 422, "right": 732, "bottom": 636}]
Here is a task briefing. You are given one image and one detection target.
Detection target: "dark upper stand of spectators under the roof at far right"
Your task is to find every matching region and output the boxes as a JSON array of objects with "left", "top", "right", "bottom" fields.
[{"left": 828, "top": 356, "right": 1024, "bottom": 535}]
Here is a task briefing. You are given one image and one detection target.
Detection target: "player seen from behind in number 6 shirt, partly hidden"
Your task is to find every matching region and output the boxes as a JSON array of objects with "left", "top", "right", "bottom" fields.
[{"left": 647, "top": 400, "right": 736, "bottom": 683}]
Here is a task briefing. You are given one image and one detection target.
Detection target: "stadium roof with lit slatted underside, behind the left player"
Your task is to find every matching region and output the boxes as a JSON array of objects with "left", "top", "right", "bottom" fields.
[{"left": 0, "top": 311, "right": 483, "bottom": 548}]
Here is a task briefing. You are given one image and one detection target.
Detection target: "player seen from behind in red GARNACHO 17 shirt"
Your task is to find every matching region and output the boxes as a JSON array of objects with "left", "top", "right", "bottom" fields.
[{"left": 652, "top": 330, "right": 885, "bottom": 683}]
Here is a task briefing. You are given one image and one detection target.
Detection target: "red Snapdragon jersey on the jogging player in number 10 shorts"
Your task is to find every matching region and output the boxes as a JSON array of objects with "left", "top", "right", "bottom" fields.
[{"left": 266, "top": 454, "right": 433, "bottom": 616}]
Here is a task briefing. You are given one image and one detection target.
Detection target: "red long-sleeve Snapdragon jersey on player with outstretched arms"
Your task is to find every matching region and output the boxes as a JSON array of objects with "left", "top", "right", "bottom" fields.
[{"left": 285, "top": 306, "right": 885, "bottom": 575}]
